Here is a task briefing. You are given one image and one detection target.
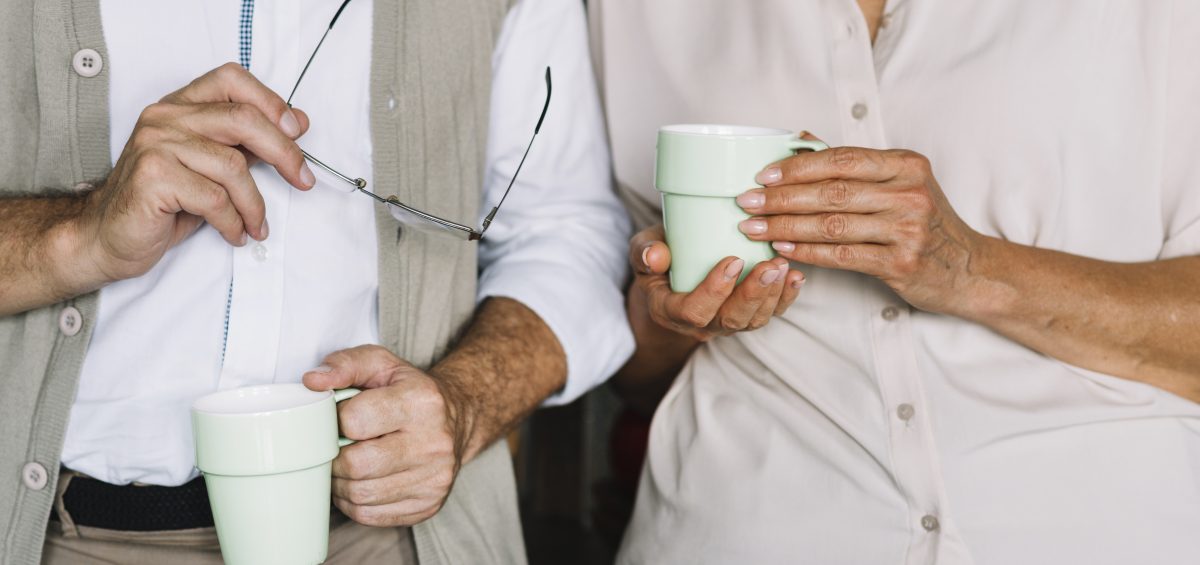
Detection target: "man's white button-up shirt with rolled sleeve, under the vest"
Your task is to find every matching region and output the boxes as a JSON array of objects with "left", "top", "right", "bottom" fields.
[{"left": 62, "top": 0, "right": 632, "bottom": 486}]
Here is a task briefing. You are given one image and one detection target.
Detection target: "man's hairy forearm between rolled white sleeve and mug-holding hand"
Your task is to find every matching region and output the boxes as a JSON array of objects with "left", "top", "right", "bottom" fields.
[{"left": 430, "top": 297, "right": 566, "bottom": 462}]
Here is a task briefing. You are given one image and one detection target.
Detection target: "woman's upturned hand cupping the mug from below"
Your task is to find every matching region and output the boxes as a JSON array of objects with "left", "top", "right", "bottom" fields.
[{"left": 629, "top": 226, "right": 804, "bottom": 341}]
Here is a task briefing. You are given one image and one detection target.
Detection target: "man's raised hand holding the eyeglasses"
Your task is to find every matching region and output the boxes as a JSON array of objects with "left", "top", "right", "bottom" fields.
[{"left": 73, "top": 64, "right": 314, "bottom": 287}]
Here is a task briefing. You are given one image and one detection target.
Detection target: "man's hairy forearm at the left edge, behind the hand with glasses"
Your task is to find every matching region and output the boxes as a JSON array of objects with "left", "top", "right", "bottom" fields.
[{"left": 0, "top": 194, "right": 98, "bottom": 315}]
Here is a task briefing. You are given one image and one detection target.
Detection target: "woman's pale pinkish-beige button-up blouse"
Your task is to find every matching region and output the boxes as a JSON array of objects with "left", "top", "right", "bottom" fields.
[{"left": 590, "top": 0, "right": 1200, "bottom": 565}]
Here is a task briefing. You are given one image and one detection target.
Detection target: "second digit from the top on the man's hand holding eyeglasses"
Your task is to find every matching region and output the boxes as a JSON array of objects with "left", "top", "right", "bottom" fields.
[{"left": 179, "top": 102, "right": 316, "bottom": 190}]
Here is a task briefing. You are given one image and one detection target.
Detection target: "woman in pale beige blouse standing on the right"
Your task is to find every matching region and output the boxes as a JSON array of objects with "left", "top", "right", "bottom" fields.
[{"left": 590, "top": 0, "right": 1200, "bottom": 565}]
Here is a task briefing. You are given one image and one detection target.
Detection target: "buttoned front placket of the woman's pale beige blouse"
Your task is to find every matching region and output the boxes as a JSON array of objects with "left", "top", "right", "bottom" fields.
[{"left": 827, "top": 0, "right": 946, "bottom": 565}]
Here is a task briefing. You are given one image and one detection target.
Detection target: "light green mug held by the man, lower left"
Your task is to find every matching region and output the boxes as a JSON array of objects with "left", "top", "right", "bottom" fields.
[{"left": 192, "top": 383, "right": 359, "bottom": 565}]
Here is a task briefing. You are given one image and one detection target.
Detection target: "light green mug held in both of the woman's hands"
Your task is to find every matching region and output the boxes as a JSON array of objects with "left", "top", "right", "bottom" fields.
[{"left": 654, "top": 124, "right": 828, "bottom": 293}]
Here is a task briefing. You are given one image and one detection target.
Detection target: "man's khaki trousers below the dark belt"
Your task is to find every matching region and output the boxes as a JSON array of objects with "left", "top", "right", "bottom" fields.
[{"left": 42, "top": 471, "right": 418, "bottom": 565}]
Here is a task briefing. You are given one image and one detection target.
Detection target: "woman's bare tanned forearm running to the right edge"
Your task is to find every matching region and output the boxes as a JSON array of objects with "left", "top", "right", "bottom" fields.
[{"left": 952, "top": 238, "right": 1200, "bottom": 402}]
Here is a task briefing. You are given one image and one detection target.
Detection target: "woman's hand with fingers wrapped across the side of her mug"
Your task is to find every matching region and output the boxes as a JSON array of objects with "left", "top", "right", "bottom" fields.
[{"left": 738, "top": 148, "right": 989, "bottom": 313}]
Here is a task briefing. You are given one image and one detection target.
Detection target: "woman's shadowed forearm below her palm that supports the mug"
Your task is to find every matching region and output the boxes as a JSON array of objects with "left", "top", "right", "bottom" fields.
[{"left": 612, "top": 285, "right": 700, "bottom": 415}]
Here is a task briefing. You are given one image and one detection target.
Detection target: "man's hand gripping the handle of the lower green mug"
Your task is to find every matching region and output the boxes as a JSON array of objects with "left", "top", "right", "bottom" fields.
[{"left": 304, "top": 345, "right": 469, "bottom": 527}]
